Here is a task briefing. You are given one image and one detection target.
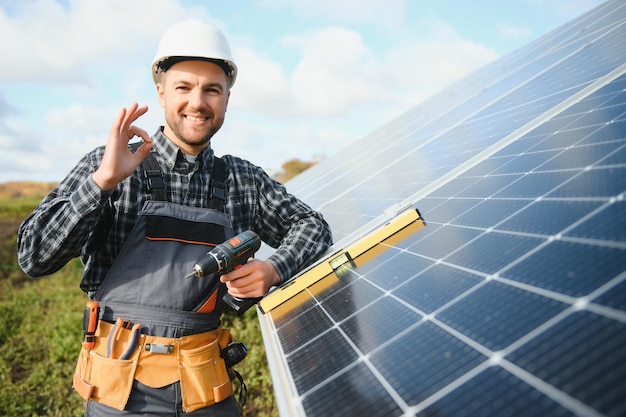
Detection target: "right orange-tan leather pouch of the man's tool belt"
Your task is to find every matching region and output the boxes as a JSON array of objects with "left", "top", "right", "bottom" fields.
[{"left": 179, "top": 334, "right": 233, "bottom": 412}]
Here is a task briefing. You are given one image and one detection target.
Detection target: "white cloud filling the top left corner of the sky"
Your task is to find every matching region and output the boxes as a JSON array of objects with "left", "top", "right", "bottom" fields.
[{"left": 0, "top": 0, "right": 217, "bottom": 84}]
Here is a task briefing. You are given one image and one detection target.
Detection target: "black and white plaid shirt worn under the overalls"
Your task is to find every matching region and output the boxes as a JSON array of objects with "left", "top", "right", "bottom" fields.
[{"left": 18, "top": 129, "right": 332, "bottom": 293}]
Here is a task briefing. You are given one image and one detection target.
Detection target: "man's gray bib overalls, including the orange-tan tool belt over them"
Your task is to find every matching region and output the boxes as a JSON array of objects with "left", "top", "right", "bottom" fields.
[{"left": 74, "top": 154, "right": 238, "bottom": 415}]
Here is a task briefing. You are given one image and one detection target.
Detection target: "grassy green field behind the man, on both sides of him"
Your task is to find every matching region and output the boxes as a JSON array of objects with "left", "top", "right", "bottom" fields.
[{"left": 0, "top": 183, "right": 277, "bottom": 417}]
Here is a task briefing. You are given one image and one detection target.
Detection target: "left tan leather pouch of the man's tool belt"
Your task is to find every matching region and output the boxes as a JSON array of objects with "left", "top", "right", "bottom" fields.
[{"left": 77, "top": 351, "right": 137, "bottom": 410}]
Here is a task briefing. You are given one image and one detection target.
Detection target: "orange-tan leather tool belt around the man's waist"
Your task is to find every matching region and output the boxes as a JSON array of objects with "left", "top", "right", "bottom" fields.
[{"left": 73, "top": 320, "right": 233, "bottom": 413}]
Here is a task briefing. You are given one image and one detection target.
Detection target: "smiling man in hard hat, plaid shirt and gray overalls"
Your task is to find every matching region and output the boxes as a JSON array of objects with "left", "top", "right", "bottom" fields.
[{"left": 18, "top": 20, "right": 332, "bottom": 417}]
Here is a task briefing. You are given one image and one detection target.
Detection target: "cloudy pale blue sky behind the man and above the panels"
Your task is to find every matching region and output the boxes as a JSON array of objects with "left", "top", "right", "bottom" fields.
[{"left": 0, "top": 0, "right": 603, "bottom": 183}]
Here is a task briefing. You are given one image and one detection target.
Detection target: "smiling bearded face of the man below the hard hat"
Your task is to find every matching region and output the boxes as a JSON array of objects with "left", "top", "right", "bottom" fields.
[{"left": 157, "top": 61, "right": 230, "bottom": 155}]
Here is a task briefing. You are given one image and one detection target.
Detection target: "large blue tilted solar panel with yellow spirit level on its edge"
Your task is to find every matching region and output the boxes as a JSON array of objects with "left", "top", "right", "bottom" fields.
[{"left": 259, "top": 0, "right": 626, "bottom": 417}]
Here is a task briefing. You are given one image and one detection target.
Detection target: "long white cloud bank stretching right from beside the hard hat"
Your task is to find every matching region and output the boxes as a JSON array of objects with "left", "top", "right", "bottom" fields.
[{"left": 231, "top": 24, "right": 497, "bottom": 119}]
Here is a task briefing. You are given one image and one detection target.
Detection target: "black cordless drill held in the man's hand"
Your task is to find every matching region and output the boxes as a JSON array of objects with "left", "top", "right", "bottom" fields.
[{"left": 187, "top": 230, "right": 261, "bottom": 316}]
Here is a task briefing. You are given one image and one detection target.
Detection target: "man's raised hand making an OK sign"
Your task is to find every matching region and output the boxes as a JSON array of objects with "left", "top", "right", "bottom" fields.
[{"left": 92, "top": 103, "right": 152, "bottom": 190}]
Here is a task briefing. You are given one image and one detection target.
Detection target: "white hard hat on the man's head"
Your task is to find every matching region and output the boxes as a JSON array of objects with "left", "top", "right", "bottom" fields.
[{"left": 152, "top": 19, "right": 237, "bottom": 88}]
